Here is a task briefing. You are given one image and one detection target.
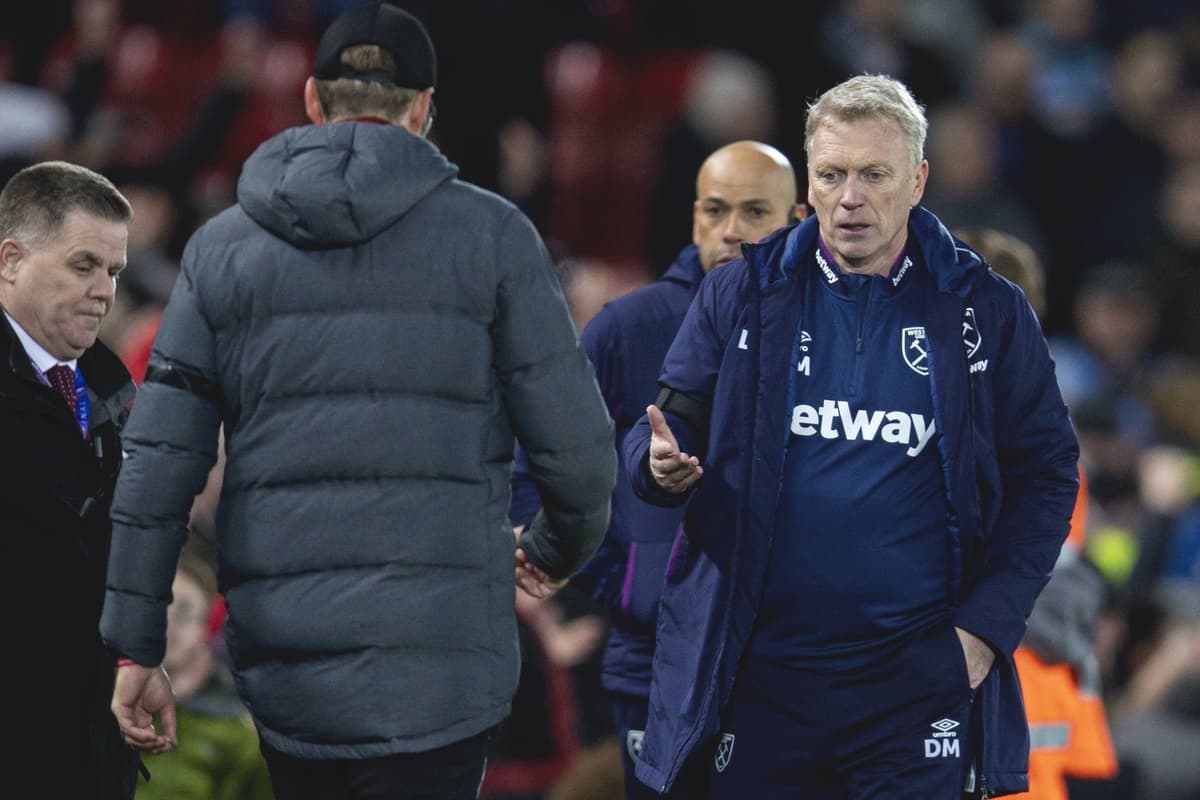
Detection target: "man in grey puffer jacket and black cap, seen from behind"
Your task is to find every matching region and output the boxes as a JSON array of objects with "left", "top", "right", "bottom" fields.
[{"left": 101, "top": 2, "right": 616, "bottom": 800}]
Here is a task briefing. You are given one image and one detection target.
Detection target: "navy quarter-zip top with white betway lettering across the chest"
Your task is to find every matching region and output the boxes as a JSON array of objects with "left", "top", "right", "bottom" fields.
[{"left": 748, "top": 239, "right": 949, "bottom": 671}]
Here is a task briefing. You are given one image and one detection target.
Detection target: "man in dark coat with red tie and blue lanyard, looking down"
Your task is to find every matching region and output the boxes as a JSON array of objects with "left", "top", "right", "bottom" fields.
[{"left": 0, "top": 162, "right": 138, "bottom": 800}]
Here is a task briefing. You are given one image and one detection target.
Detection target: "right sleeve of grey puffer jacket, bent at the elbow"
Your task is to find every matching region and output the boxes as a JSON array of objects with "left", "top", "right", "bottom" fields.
[{"left": 492, "top": 212, "right": 617, "bottom": 578}]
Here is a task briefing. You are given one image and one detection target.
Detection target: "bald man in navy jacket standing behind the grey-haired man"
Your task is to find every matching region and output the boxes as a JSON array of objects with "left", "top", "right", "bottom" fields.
[{"left": 512, "top": 142, "right": 805, "bottom": 799}]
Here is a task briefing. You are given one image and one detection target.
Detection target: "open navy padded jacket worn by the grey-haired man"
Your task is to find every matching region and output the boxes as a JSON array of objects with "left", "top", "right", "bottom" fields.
[{"left": 624, "top": 207, "right": 1079, "bottom": 795}]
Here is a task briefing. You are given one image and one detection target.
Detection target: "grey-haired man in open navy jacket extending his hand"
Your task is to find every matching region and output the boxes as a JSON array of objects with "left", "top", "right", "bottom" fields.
[{"left": 624, "top": 77, "right": 1078, "bottom": 800}]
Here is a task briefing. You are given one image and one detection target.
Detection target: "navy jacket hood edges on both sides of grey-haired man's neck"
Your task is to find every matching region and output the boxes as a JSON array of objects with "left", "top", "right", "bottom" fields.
[{"left": 742, "top": 206, "right": 988, "bottom": 296}]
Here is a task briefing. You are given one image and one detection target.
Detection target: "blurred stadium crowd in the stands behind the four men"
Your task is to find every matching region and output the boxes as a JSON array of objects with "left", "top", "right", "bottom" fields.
[{"left": 0, "top": 0, "right": 1200, "bottom": 800}]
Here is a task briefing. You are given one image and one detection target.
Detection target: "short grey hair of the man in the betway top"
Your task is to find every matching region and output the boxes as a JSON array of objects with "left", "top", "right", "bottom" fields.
[{"left": 804, "top": 76, "right": 929, "bottom": 169}]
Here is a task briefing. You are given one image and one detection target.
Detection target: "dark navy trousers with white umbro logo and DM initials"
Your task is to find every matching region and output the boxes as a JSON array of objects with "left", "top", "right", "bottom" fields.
[{"left": 710, "top": 621, "right": 974, "bottom": 800}]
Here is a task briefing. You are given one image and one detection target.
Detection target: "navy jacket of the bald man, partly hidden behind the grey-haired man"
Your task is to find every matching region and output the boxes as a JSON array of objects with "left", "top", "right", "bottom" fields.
[{"left": 511, "top": 245, "right": 704, "bottom": 697}]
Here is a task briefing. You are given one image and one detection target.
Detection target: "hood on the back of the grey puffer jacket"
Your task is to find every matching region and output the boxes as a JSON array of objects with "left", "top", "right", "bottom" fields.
[{"left": 238, "top": 121, "right": 458, "bottom": 248}]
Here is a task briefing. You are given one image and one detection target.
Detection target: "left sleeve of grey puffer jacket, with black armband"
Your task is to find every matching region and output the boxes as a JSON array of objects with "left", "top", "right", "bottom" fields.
[{"left": 100, "top": 239, "right": 221, "bottom": 666}]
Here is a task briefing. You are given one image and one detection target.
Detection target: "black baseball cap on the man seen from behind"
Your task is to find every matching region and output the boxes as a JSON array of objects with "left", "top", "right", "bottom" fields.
[{"left": 312, "top": 0, "right": 438, "bottom": 89}]
